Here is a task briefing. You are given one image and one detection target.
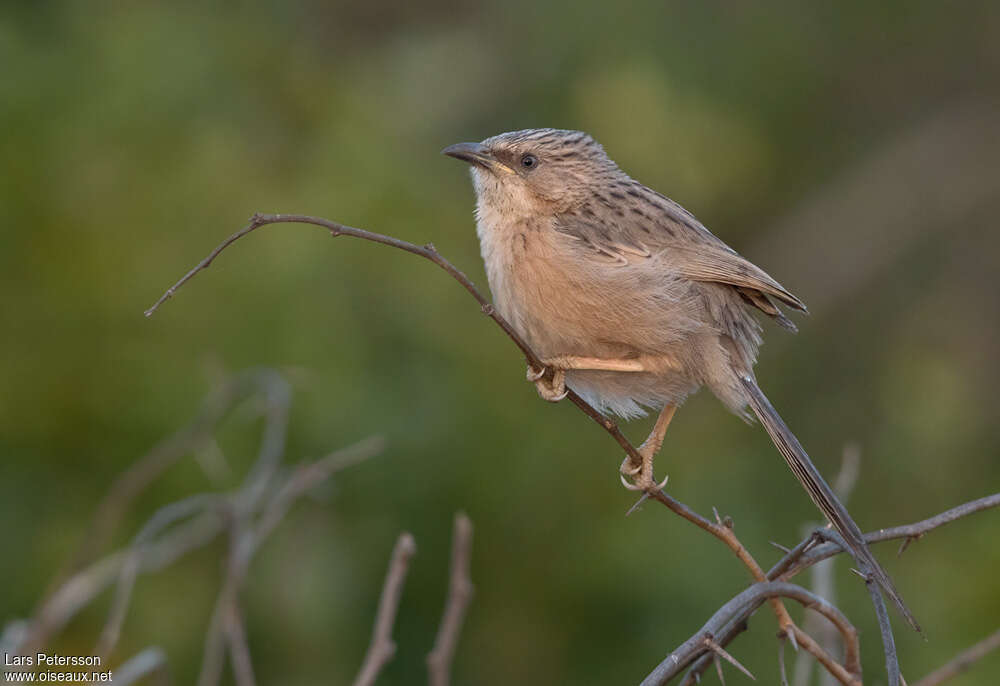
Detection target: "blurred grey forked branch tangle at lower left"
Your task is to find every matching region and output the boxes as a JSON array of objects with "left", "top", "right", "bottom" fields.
[{"left": 9, "top": 370, "right": 383, "bottom": 686}]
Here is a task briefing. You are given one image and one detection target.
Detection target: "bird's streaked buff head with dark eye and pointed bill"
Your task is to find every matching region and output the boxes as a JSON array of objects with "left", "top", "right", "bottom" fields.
[{"left": 441, "top": 129, "right": 621, "bottom": 215}]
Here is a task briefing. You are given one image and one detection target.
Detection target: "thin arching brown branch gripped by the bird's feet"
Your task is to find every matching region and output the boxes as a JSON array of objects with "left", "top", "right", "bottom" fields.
[{"left": 145, "top": 214, "right": 1000, "bottom": 686}]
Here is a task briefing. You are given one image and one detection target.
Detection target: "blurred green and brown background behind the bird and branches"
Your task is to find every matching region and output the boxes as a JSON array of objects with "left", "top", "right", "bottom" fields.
[{"left": 0, "top": 0, "right": 1000, "bottom": 686}]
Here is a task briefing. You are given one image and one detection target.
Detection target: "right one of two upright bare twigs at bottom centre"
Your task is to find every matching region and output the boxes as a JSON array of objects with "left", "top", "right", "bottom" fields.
[{"left": 427, "top": 512, "right": 473, "bottom": 686}]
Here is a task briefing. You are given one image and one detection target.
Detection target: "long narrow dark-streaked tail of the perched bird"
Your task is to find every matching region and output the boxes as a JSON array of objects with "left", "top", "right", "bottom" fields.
[{"left": 740, "top": 375, "right": 920, "bottom": 631}]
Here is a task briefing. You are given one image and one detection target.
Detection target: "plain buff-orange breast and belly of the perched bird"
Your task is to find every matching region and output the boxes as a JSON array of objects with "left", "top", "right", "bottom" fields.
[{"left": 483, "top": 226, "right": 699, "bottom": 417}]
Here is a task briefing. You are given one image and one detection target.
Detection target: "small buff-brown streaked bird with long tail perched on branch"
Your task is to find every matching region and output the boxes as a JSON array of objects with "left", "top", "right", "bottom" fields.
[{"left": 450, "top": 129, "right": 919, "bottom": 630}]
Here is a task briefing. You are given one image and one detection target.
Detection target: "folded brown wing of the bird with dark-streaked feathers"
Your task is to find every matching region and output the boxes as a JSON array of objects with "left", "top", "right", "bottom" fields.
[{"left": 555, "top": 183, "right": 807, "bottom": 329}]
